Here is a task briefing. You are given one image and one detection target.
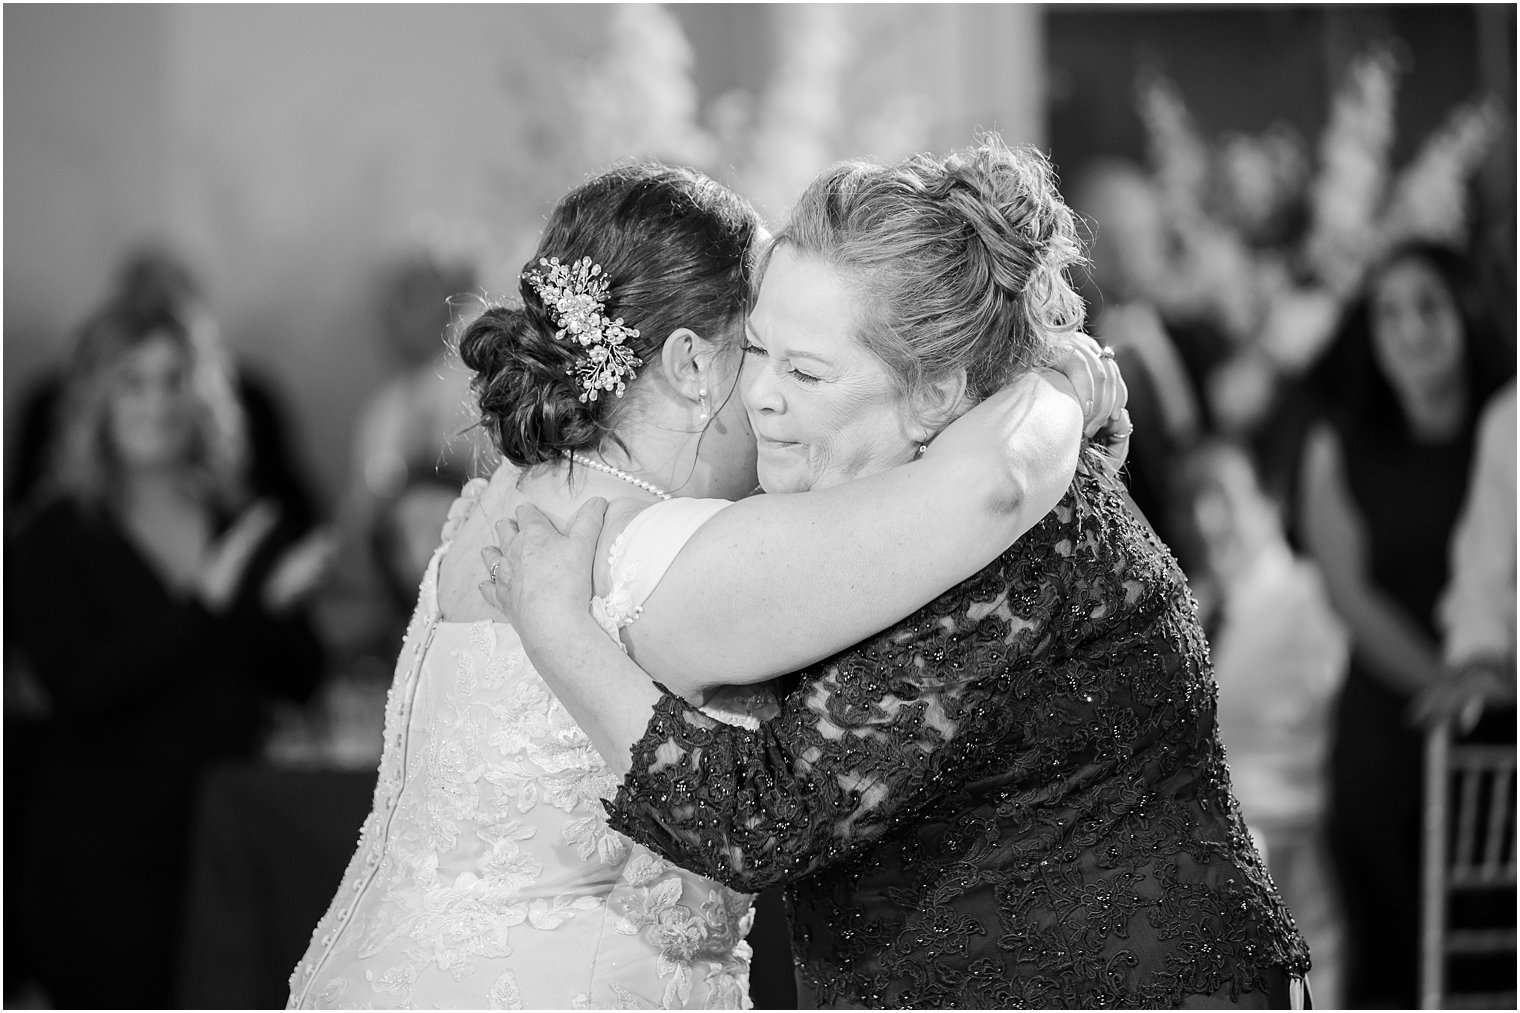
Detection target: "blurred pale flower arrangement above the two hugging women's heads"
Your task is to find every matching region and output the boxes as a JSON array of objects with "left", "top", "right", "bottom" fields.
[{"left": 410, "top": 3, "right": 933, "bottom": 301}]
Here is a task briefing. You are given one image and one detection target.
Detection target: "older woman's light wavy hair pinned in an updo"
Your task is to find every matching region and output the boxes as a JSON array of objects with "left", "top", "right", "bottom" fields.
[{"left": 772, "top": 134, "right": 1084, "bottom": 426}]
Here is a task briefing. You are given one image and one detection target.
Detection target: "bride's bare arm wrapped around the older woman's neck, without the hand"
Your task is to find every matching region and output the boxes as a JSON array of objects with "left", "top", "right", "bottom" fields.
[{"left": 623, "top": 366, "right": 1082, "bottom": 695}]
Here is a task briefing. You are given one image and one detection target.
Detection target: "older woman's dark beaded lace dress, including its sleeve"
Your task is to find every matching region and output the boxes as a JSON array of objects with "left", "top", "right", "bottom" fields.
[{"left": 608, "top": 467, "right": 1309, "bottom": 1008}]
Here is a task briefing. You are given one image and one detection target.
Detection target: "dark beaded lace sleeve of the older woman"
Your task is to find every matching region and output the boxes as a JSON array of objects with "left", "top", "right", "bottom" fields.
[{"left": 608, "top": 486, "right": 1094, "bottom": 893}]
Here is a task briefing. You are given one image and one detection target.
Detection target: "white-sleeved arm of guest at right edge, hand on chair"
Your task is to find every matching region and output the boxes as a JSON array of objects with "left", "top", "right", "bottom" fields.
[{"left": 1417, "top": 380, "right": 1515, "bottom": 720}]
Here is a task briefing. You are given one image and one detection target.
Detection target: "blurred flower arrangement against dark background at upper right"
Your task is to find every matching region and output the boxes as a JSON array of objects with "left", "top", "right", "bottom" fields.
[{"left": 1137, "top": 49, "right": 1503, "bottom": 432}]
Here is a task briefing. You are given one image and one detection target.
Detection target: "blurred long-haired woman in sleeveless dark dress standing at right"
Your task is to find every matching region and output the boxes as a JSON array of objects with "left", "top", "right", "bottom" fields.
[{"left": 1298, "top": 245, "right": 1514, "bottom": 1008}]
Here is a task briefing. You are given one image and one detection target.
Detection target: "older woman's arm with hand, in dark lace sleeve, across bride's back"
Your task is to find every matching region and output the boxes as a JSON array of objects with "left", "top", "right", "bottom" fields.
[{"left": 492, "top": 500, "right": 1057, "bottom": 891}]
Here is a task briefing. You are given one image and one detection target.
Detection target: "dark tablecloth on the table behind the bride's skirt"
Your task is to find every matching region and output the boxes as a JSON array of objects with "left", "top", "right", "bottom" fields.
[{"left": 179, "top": 764, "right": 796, "bottom": 1010}]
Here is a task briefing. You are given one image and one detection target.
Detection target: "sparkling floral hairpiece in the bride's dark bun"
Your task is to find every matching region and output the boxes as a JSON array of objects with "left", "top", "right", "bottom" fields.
[{"left": 523, "top": 257, "right": 644, "bottom": 403}]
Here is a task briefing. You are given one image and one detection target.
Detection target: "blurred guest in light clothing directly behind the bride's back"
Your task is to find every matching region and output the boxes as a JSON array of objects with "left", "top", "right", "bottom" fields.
[{"left": 321, "top": 252, "right": 485, "bottom": 681}]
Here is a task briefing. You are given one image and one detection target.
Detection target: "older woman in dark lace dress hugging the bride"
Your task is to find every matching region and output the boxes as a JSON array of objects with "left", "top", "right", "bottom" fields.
[{"left": 485, "top": 138, "right": 1309, "bottom": 1008}]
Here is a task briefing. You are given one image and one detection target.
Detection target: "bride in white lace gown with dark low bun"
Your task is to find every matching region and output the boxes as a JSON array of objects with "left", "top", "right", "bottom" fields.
[{"left": 290, "top": 164, "right": 1123, "bottom": 1008}]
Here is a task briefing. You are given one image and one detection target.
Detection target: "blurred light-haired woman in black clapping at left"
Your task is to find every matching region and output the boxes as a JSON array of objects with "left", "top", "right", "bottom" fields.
[{"left": 5, "top": 301, "right": 327, "bottom": 1008}]
